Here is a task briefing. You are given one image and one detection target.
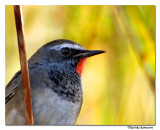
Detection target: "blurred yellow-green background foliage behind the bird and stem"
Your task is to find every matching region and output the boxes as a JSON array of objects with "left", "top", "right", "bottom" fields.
[{"left": 5, "top": 5, "right": 155, "bottom": 125}]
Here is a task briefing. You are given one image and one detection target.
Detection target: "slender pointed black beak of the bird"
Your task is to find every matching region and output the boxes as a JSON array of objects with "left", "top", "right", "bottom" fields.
[{"left": 73, "top": 50, "right": 105, "bottom": 58}]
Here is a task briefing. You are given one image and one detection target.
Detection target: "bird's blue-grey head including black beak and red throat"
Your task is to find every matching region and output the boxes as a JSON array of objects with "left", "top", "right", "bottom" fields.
[{"left": 29, "top": 39, "right": 105, "bottom": 76}]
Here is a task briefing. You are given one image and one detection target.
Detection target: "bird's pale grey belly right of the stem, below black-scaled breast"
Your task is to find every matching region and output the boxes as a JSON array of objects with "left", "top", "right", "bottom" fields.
[{"left": 33, "top": 89, "right": 81, "bottom": 125}]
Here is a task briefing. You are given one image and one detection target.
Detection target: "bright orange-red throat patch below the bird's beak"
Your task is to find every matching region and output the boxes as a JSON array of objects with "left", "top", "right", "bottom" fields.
[{"left": 76, "top": 58, "right": 87, "bottom": 76}]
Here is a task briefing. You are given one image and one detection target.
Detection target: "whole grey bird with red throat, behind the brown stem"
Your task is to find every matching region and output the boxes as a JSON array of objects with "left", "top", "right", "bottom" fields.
[{"left": 5, "top": 39, "right": 105, "bottom": 125}]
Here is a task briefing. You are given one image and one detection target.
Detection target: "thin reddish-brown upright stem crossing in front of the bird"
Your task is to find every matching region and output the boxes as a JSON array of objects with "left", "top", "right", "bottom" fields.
[{"left": 14, "top": 5, "right": 34, "bottom": 125}]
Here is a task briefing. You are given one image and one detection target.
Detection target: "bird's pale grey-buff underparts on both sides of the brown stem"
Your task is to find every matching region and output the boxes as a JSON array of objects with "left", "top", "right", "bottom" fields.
[{"left": 6, "top": 85, "right": 81, "bottom": 125}]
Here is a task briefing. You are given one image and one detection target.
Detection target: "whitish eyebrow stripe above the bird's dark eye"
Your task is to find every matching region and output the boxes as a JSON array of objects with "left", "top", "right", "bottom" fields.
[{"left": 50, "top": 43, "right": 85, "bottom": 50}]
